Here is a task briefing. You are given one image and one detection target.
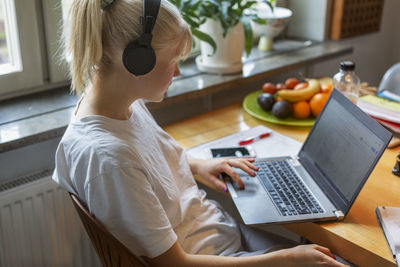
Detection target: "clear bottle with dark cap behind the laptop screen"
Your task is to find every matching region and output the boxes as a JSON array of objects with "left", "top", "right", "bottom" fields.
[{"left": 333, "top": 61, "right": 360, "bottom": 104}]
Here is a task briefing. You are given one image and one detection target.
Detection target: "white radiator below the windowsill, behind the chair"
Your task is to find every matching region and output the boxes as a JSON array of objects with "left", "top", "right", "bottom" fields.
[{"left": 0, "top": 170, "right": 101, "bottom": 267}]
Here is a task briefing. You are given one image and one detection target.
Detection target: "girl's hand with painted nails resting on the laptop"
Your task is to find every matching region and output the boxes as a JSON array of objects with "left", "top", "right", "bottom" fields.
[{"left": 189, "top": 158, "right": 258, "bottom": 193}]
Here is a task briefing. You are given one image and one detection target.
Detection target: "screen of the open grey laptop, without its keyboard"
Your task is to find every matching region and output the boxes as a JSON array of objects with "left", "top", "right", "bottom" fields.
[{"left": 302, "top": 93, "right": 387, "bottom": 202}]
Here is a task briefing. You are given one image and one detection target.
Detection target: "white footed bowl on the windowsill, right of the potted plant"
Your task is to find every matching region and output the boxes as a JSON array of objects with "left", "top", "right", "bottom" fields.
[{"left": 251, "top": 2, "right": 293, "bottom": 51}]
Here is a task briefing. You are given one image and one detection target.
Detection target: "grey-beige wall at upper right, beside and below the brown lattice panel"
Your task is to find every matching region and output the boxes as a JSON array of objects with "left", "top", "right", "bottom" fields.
[{"left": 313, "top": 0, "right": 400, "bottom": 86}]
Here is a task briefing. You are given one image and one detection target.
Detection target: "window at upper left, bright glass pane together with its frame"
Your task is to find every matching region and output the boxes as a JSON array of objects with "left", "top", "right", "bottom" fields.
[{"left": 0, "top": 0, "right": 67, "bottom": 99}]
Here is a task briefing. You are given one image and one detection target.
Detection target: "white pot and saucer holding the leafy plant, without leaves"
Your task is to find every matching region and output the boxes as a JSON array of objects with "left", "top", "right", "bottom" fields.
[{"left": 196, "top": 19, "right": 244, "bottom": 74}]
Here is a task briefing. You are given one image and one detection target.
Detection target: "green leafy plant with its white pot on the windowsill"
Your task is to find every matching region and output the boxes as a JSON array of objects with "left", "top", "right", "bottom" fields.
[{"left": 170, "top": 0, "right": 275, "bottom": 74}]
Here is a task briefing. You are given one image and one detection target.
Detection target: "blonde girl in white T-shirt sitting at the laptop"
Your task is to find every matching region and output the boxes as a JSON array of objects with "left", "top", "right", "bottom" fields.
[{"left": 53, "top": 0, "right": 344, "bottom": 267}]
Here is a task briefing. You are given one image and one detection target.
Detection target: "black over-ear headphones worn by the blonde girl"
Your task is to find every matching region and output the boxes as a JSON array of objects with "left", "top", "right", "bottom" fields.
[{"left": 122, "top": 0, "right": 161, "bottom": 76}]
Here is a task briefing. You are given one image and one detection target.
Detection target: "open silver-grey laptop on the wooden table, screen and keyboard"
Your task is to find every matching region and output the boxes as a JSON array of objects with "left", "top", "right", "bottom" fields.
[{"left": 226, "top": 89, "right": 392, "bottom": 225}]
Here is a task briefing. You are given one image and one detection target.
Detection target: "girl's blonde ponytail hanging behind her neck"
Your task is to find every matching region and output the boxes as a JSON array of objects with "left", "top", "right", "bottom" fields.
[{"left": 64, "top": 0, "right": 103, "bottom": 95}]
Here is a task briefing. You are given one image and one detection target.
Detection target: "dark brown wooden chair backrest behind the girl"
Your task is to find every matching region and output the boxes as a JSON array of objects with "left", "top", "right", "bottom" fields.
[{"left": 69, "top": 193, "right": 145, "bottom": 267}]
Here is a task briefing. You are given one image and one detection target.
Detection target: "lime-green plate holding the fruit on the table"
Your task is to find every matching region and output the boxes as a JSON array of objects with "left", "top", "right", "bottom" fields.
[{"left": 243, "top": 91, "right": 315, "bottom": 126}]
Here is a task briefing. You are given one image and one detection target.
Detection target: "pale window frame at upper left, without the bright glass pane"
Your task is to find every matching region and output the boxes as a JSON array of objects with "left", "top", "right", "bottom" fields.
[{"left": 0, "top": 0, "right": 69, "bottom": 100}]
